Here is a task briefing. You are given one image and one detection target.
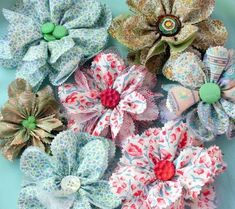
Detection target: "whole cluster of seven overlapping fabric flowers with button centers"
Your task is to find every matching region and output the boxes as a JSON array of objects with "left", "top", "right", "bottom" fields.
[{"left": 0, "top": 0, "right": 235, "bottom": 209}]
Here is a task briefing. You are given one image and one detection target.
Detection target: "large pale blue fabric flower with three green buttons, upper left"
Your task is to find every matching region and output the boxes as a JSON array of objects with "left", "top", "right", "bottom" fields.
[{"left": 0, "top": 0, "right": 112, "bottom": 87}]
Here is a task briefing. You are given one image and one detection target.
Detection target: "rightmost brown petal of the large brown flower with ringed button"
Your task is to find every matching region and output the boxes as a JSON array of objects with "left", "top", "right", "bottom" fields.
[{"left": 193, "top": 19, "right": 228, "bottom": 51}]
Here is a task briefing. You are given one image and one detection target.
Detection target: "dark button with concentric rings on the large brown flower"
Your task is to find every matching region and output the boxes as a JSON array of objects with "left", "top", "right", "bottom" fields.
[{"left": 157, "top": 15, "right": 181, "bottom": 36}]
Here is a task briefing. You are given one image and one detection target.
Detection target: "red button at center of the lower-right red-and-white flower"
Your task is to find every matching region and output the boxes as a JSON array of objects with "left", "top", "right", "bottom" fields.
[{"left": 154, "top": 160, "right": 175, "bottom": 181}]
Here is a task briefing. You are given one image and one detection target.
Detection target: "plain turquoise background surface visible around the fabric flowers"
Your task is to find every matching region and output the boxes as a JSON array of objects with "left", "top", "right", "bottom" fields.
[{"left": 0, "top": 0, "right": 235, "bottom": 209}]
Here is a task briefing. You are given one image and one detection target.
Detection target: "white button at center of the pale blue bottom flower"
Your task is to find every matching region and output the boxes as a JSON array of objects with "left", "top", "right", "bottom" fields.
[{"left": 60, "top": 176, "right": 81, "bottom": 194}]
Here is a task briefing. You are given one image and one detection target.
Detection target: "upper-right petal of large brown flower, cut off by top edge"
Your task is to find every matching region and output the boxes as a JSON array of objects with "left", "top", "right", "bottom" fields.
[{"left": 172, "top": 0, "right": 215, "bottom": 24}]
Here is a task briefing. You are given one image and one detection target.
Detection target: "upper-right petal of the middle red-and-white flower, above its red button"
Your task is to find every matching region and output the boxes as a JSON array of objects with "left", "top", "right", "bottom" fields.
[{"left": 113, "top": 65, "right": 147, "bottom": 95}]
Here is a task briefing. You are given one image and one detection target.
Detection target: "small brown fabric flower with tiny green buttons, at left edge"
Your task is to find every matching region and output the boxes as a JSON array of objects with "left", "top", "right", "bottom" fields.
[{"left": 0, "top": 79, "right": 63, "bottom": 160}]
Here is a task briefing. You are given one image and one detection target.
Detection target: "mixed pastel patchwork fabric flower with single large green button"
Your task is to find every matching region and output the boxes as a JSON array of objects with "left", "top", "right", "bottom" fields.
[{"left": 167, "top": 47, "right": 235, "bottom": 141}]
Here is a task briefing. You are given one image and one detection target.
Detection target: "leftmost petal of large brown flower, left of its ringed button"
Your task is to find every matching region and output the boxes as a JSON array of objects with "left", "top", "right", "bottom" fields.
[{"left": 109, "top": 14, "right": 159, "bottom": 50}]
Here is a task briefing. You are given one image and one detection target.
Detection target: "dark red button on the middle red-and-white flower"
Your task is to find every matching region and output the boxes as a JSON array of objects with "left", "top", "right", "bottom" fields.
[{"left": 100, "top": 89, "right": 121, "bottom": 109}]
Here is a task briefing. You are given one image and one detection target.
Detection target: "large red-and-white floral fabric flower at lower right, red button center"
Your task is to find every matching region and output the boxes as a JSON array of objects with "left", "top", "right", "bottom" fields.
[{"left": 110, "top": 122, "right": 225, "bottom": 209}]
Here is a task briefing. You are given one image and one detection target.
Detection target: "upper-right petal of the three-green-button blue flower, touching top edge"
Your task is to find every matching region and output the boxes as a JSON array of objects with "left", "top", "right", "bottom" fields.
[{"left": 61, "top": 0, "right": 102, "bottom": 29}]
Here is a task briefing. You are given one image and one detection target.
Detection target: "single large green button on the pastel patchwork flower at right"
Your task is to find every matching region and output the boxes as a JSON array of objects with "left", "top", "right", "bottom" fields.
[{"left": 199, "top": 83, "right": 221, "bottom": 104}]
